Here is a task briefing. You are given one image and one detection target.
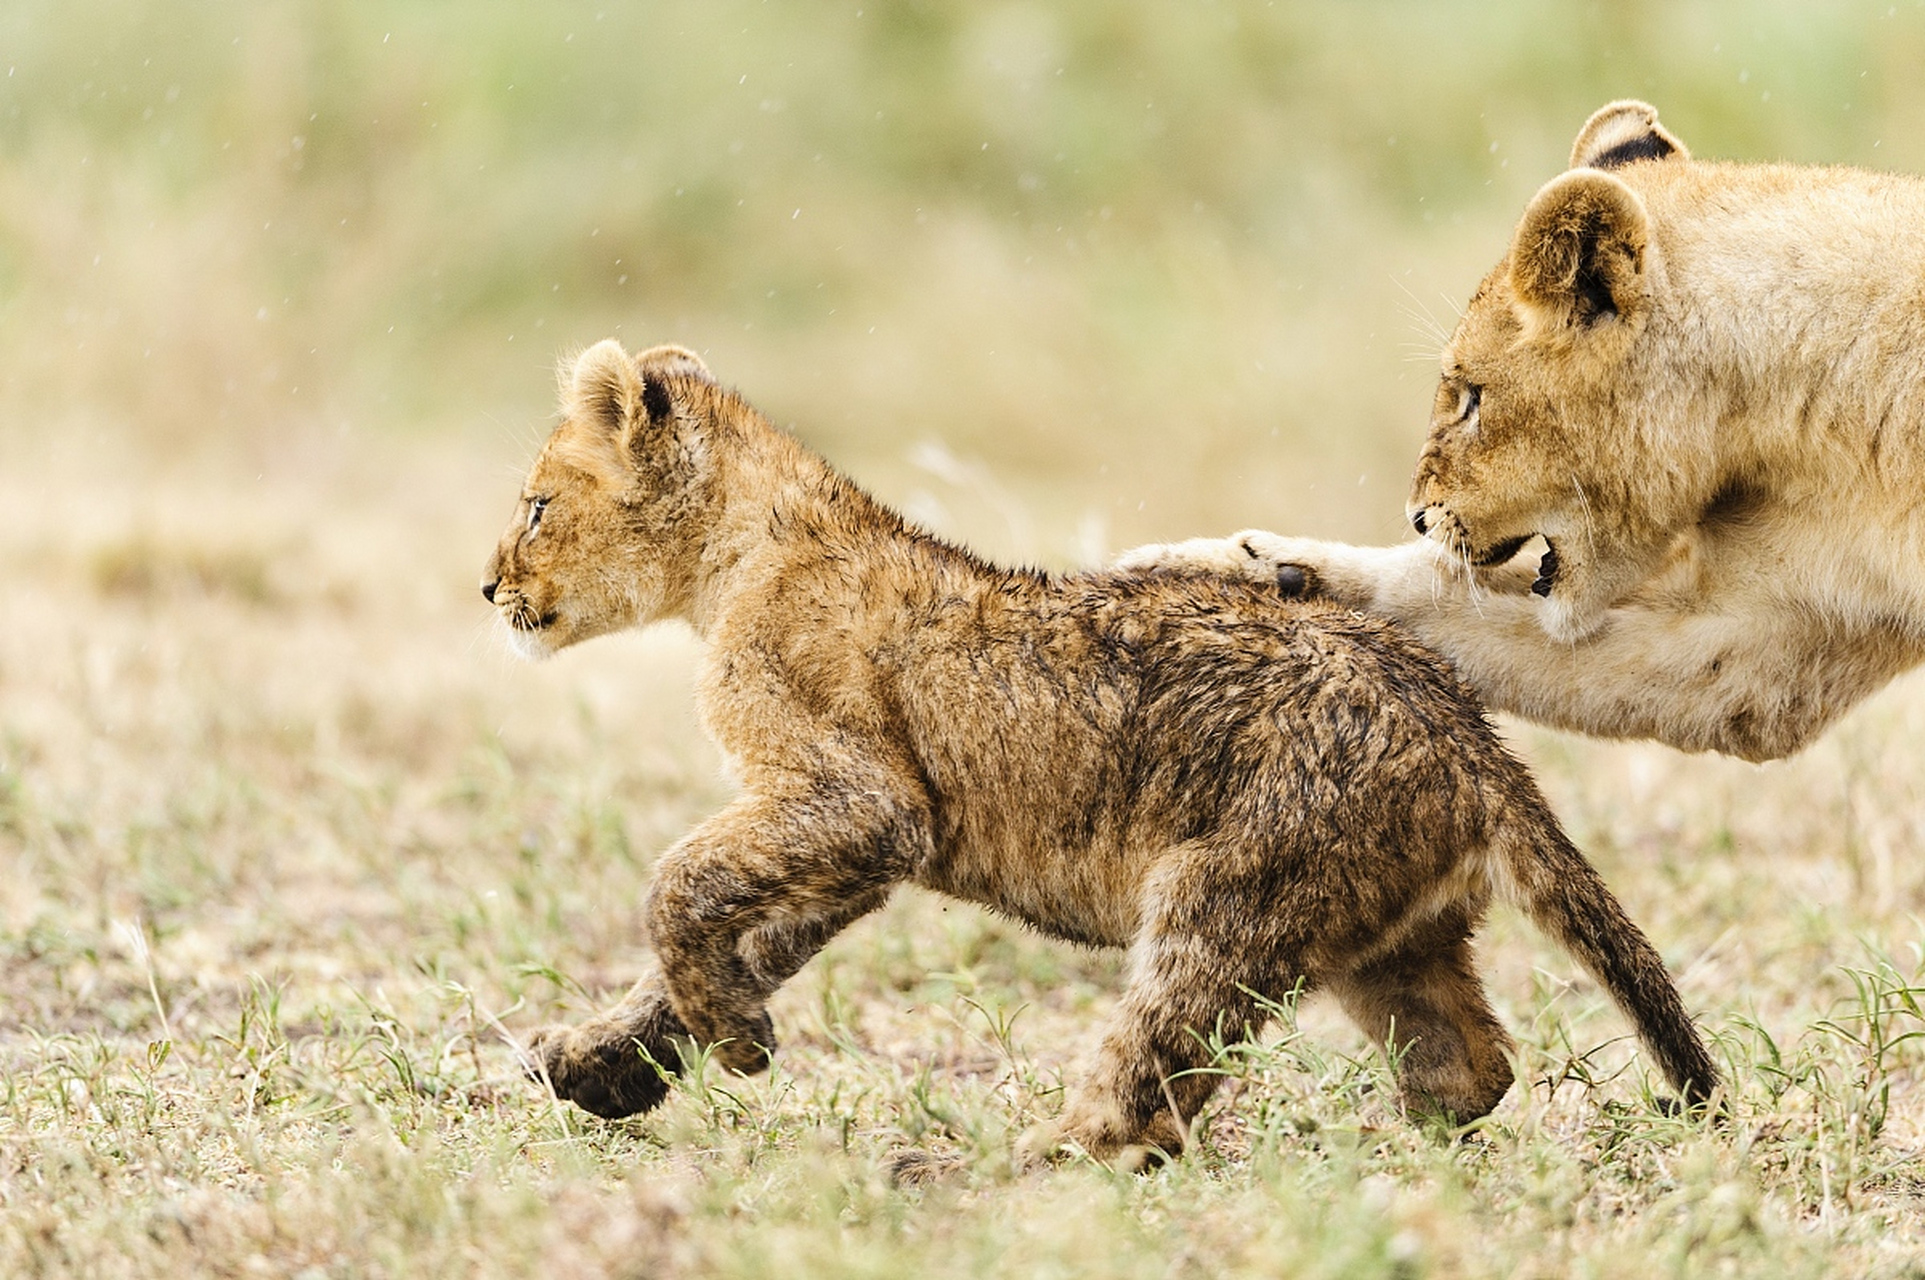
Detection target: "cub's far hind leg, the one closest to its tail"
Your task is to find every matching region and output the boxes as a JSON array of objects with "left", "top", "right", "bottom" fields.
[{"left": 1330, "top": 903, "right": 1513, "bottom": 1124}]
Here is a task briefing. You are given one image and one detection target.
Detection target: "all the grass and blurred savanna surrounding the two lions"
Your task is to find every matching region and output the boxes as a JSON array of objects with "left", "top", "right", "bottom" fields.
[{"left": 0, "top": 0, "right": 1925, "bottom": 1280}]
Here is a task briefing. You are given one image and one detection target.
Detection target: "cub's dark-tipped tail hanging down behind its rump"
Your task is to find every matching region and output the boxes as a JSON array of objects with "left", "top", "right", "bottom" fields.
[{"left": 1492, "top": 787, "right": 1717, "bottom": 1105}]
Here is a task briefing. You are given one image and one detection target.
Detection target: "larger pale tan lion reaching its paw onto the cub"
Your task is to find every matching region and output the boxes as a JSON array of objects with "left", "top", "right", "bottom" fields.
[{"left": 1120, "top": 102, "right": 1925, "bottom": 760}]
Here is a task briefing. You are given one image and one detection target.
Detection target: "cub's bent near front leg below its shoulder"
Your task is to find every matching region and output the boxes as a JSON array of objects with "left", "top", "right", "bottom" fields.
[{"left": 647, "top": 780, "right": 926, "bottom": 1074}]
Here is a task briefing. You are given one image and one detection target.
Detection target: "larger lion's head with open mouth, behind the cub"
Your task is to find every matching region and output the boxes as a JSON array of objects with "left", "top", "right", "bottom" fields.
[{"left": 1409, "top": 102, "right": 1688, "bottom": 639}]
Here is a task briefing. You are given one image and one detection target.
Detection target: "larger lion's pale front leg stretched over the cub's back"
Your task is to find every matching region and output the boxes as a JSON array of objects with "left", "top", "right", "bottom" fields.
[{"left": 1118, "top": 529, "right": 1921, "bottom": 760}]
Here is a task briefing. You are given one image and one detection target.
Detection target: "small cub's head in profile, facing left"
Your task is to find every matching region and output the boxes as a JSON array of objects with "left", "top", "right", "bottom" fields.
[{"left": 481, "top": 339, "right": 712, "bottom": 658}]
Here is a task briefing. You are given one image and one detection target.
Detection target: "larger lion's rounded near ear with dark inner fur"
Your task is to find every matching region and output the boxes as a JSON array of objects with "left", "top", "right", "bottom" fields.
[{"left": 1511, "top": 169, "right": 1650, "bottom": 335}]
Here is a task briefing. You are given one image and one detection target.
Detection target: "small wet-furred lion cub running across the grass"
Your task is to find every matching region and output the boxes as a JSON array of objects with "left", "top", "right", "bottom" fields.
[{"left": 481, "top": 341, "right": 1717, "bottom": 1163}]
